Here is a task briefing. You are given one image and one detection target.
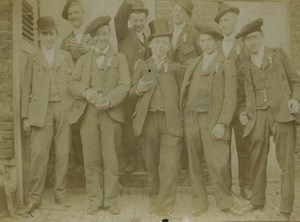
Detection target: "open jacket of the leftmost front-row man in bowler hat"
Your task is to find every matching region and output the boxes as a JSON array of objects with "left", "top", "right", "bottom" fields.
[{"left": 21, "top": 48, "right": 74, "bottom": 127}]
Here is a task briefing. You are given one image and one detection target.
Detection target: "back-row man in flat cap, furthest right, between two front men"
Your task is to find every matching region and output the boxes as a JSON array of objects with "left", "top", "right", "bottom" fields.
[{"left": 215, "top": 4, "right": 251, "bottom": 200}]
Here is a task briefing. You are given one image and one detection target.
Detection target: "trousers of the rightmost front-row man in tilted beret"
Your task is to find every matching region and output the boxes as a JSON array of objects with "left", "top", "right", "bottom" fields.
[{"left": 246, "top": 109, "right": 295, "bottom": 213}]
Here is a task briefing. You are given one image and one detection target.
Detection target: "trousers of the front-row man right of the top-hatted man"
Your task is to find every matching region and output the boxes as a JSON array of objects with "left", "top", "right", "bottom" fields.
[{"left": 184, "top": 112, "right": 234, "bottom": 210}]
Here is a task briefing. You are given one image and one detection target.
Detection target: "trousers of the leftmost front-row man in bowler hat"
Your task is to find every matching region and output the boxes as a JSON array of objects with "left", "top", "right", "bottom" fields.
[{"left": 28, "top": 102, "right": 71, "bottom": 204}]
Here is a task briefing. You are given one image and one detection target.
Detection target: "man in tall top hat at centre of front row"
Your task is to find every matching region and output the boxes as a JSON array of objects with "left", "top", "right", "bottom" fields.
[{"left": 130, "top": 19, "right": 183, "bottom": 219}]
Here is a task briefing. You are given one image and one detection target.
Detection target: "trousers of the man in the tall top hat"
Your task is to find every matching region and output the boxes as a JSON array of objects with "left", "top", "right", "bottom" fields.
[{"left": 141, "top": 111, "right": 182, "bottom": 211}]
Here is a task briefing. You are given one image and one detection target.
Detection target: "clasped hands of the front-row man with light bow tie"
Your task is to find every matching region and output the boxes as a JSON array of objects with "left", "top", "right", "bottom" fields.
[{"left": 83, "top": 89, "right": 112, "bottom": 110}]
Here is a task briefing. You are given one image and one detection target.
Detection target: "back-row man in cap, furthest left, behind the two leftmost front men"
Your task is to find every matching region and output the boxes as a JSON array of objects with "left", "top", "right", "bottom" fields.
[{"left": 60, "top": 0, "right": 91, "bottom": 171}]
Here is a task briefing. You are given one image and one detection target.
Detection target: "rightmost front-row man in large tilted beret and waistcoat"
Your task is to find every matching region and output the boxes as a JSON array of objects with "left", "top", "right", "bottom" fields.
[{"left": 236, "top": 19, "right": 300, "bottom": 221}]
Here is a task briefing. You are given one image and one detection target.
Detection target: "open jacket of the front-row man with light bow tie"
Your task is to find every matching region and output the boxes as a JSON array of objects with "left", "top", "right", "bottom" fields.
[{"left": 69, "top": 49, "right": 130, "bottom": 123}]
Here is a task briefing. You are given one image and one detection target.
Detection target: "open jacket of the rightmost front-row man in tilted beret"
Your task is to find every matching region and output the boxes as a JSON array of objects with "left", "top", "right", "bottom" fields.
[{"left": 239, "top": 47, "right": 300, "bottom": 137}]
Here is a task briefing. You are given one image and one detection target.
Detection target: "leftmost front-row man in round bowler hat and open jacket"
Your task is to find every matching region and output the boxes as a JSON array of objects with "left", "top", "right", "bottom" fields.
[{"left": 19, "top": 16, "right": 74, "bottom": 214}]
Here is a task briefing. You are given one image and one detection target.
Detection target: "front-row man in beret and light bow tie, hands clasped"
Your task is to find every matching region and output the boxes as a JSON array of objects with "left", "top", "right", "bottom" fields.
[{"left": 69, "top": 16, "right": 130, "bottom": 214}]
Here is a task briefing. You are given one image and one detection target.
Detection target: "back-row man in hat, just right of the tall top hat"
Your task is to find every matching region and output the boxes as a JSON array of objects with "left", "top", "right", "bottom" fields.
[{"left": 171, "top": 0, "right": 201, "bottom": 64}]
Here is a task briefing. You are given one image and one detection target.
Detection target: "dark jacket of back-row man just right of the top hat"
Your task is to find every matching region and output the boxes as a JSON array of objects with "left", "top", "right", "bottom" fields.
[{"left": 171, "top": 24, "right": 201, "bottom": 64}]
